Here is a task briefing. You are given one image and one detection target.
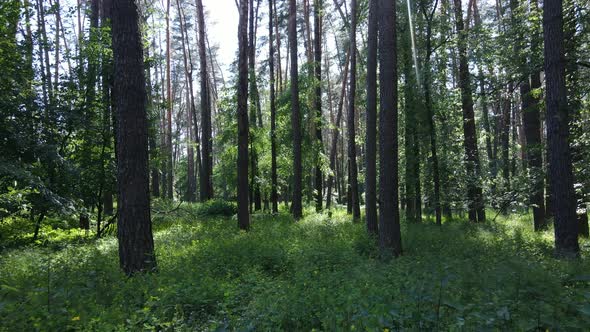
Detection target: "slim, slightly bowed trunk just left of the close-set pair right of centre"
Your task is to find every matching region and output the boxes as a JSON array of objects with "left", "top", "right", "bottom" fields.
[{"left": 346, "top": 0, "right": 361, "bottom": 222}]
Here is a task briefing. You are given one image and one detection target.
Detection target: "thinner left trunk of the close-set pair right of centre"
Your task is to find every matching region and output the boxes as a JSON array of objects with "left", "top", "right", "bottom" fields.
[{"left": 365, "top": 0, "right": 378, "bottom": 235}]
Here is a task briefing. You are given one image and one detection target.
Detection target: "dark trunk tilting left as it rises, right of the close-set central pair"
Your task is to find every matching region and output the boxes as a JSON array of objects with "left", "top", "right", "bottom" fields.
[{"left": 454, "top": 0, "right": 486, "bottom": 222}]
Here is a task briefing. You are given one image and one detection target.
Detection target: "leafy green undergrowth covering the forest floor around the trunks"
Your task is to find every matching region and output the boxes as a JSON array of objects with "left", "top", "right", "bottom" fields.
[{"left": 0, "top": 204, "right": 590, "bottom": 331}]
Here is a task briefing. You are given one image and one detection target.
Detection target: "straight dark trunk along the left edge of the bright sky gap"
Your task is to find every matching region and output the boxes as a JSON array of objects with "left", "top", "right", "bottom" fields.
[{"left": 196, "top": 0, "right": 213, "bottom": 202}]
